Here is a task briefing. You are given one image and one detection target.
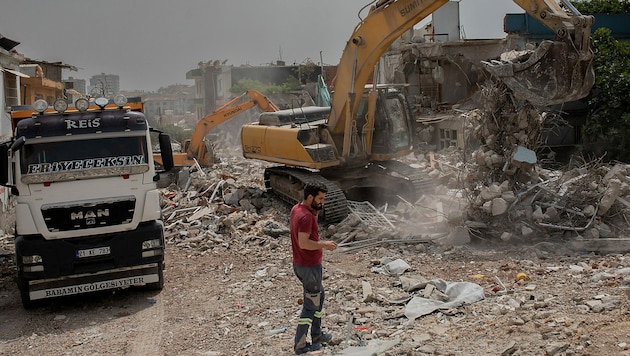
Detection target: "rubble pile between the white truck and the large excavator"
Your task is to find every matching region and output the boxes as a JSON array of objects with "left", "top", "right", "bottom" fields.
[{"left": 161, "top": 151, "right": 296, "bottom": 254}]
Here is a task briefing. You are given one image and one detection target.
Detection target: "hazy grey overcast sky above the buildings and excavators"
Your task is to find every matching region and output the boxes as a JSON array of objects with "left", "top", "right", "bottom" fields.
[{"left": 0, "top": 0, "right": 523, "bottom": 91}]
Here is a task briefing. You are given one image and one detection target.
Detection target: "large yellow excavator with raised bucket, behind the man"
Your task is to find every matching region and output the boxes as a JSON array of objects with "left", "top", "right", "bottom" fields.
[{"left": 241, "top": 0, "right": 594, "bottom": 222}]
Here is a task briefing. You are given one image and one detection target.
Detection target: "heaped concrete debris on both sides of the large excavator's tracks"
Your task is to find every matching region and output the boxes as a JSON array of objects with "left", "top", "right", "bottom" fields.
[{"left": 149, "top": 114, "right": 630, "bottom": 262}]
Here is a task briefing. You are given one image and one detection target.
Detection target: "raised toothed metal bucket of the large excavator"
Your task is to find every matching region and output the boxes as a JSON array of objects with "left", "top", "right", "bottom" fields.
[{"left": 483, "top": 40, "right": 595, "bottom": 105}]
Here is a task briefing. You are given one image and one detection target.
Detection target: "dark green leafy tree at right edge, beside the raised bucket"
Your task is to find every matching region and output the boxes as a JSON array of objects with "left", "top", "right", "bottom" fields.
[{"left": 584, "top": 28, "right": 630, "bottom": 162}]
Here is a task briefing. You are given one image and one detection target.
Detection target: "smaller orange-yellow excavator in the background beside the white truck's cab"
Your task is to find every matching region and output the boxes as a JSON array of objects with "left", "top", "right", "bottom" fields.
[{"left": 153, "top": 90, "right": 280, "bottom": 169}]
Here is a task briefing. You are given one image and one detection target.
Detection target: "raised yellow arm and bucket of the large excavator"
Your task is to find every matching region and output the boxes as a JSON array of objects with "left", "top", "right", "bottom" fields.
[{"left": 328, "top": 0, "right": 594, "bottom": 157}]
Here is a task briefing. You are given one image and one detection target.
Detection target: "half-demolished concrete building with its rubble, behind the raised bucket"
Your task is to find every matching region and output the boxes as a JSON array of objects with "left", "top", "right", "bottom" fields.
[{"left": 326, "top": 4, "right": 630, "bottom": 251}]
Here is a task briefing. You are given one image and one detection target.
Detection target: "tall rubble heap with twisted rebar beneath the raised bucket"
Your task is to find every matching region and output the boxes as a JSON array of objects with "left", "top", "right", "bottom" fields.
[{"left": 418, "top": 86, "right": 630, "bottom": 241}]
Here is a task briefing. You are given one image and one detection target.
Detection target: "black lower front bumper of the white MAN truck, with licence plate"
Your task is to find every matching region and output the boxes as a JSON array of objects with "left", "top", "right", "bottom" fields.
[{"left": 15, "top": 221, "right": 164, "bottom": 300}]
